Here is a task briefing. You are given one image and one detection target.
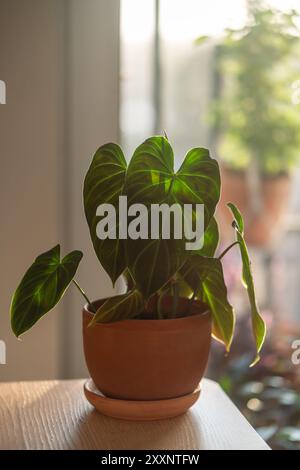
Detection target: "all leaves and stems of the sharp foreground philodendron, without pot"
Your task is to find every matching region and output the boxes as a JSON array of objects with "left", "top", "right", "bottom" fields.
[{"left": 11, "top": 136, "right": 265, "bottom": 363}]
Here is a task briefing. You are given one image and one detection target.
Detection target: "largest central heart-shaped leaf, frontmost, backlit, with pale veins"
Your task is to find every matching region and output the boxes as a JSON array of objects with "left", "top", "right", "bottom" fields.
[{"left": 125, "top": 136, "right": 220, "bottom": 298}]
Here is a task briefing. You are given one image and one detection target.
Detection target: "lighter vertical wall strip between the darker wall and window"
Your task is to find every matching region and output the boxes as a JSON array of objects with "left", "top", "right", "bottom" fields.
[{"left": 64, "top": 0, "right": 119, "bottom": 377}]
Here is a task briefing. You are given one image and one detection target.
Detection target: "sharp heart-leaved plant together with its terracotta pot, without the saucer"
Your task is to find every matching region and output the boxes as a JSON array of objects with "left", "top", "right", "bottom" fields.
[{"left": 11, "top": 136, "right": 265, "bottom": 418}]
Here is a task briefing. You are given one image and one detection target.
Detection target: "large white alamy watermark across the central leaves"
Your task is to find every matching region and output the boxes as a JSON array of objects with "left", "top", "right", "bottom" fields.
[{"left": 96, "top": 196, "right": 204, "bottom": 250}]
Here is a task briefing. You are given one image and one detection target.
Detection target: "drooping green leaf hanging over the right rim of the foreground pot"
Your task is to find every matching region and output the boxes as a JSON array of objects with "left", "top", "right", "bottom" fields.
[{"left": 181, "top": 255, "right": 235, "bottom": 351}]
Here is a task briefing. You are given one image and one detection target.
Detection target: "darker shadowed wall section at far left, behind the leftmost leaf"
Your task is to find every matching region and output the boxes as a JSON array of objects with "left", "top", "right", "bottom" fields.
[{"left": 0, "top": 0, "right": 63, "bottom": 381}]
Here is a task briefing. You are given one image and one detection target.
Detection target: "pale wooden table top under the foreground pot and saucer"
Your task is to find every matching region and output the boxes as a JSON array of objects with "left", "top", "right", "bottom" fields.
[{"left": 0, "top": 380, "right": 268, "bottom": 450}]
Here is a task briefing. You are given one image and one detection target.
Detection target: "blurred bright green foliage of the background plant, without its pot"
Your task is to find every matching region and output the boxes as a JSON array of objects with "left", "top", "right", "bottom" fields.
[{"left": 213, "top": 0, "right": 300, "bottom": 175}]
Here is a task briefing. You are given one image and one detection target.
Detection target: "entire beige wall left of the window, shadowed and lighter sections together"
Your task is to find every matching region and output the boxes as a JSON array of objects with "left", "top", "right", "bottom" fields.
[{"left": 0, "top": 0, "right": 119, "bottom": 381}]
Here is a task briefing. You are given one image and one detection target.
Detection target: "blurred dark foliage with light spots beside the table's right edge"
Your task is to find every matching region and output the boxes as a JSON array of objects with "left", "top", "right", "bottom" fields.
[{"left": 208, "top": 317, "right": 300, "bottom": 450}]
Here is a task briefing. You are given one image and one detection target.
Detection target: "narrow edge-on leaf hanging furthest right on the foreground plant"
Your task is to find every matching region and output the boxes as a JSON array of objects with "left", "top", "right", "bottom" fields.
[{"left": 227, "top": 203, "right": 266, "bottom": 366}]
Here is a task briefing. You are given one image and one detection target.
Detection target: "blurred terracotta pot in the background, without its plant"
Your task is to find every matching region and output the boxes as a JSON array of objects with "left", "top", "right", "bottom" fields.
[{"left": 217, "top": 167, "right": 291, "bottom": 246}]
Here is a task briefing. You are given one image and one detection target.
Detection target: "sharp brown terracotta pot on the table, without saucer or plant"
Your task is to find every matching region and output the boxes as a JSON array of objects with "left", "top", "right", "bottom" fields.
[{"left": 83, "top": 299, "right": 211, "bottom": 400}]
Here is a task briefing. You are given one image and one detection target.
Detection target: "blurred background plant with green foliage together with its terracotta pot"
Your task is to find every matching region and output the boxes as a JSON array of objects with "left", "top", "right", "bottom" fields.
[{"left": 199, "top": 0, "right": 300, "bottom": 246}]
